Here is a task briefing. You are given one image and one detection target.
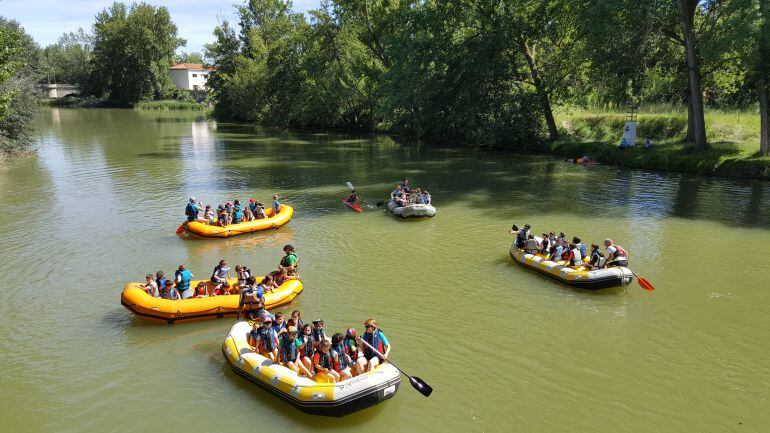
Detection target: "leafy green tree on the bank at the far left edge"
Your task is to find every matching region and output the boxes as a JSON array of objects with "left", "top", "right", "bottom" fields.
[{"left": 0, "top": 17, "right": 39, "bottom": 154}]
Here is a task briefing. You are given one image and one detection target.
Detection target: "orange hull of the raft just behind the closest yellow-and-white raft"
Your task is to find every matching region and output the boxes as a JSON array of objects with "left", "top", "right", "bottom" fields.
[{"left": 120, "top": 277, "right": 303, "bottom": 323}]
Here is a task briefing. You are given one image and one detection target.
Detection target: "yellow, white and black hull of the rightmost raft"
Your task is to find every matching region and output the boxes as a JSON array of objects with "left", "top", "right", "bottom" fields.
[{"left": 510, "top": 243, "right": 634, "bottom": 290}]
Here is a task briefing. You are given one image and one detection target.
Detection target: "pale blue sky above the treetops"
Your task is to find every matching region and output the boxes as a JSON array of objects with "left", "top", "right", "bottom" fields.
[{"left": 0, "top": 0, "right": 321, "bottom": 53}]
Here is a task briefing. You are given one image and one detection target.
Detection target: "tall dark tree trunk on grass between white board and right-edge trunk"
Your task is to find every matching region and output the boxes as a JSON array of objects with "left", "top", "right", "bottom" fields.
[{"left": 676, "top": 0, "right": 708, "bottom": 150}]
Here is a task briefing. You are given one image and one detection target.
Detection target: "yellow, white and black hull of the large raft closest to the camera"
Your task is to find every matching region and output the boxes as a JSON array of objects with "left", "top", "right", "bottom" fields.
[{"left": 222, "top": 322, "right": 401, "bottom": 416}]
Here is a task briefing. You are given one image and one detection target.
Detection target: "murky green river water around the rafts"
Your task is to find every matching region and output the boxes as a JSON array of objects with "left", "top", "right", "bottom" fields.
[{"left": 0, "top": 109, "right": 770, "bottom": 433}]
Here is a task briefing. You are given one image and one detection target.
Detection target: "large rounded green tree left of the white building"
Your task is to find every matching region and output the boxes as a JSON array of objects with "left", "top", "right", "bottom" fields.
[{"left": 91, "top": 2, "right": 184, "bottom": 105}]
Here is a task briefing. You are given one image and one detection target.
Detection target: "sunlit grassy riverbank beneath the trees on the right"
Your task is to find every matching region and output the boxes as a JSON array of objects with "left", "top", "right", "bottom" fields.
[{"left": 542, "top": 107, "right": 770, "bottom": 180}]
